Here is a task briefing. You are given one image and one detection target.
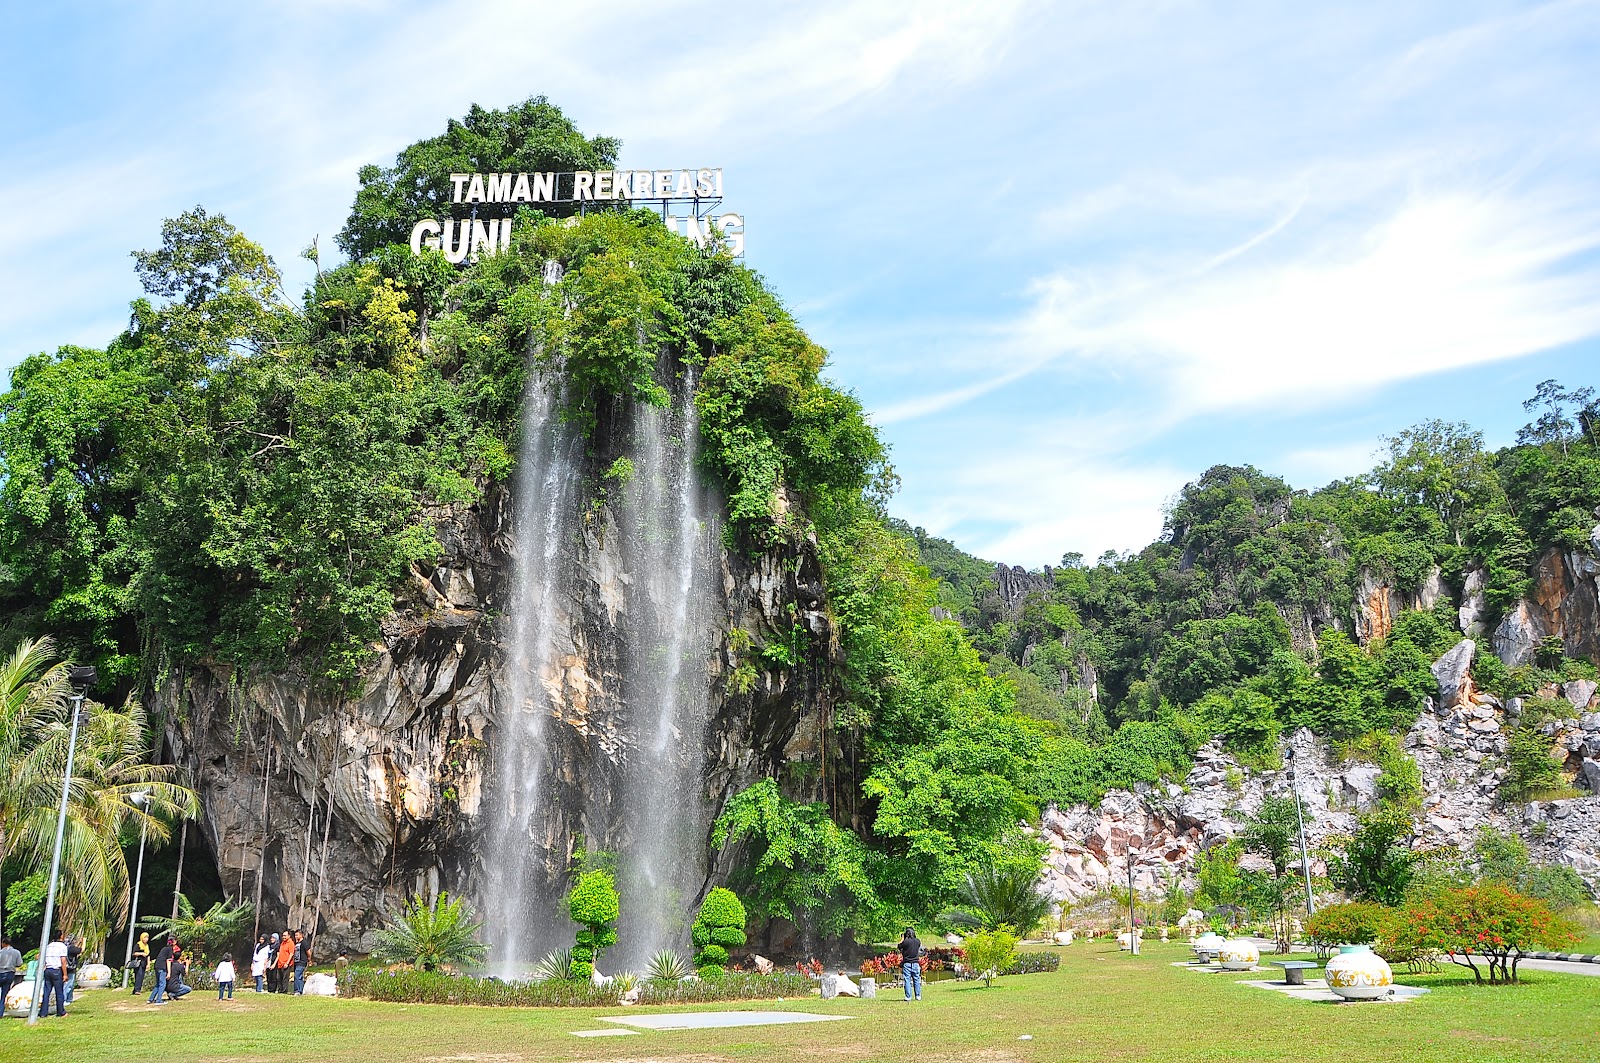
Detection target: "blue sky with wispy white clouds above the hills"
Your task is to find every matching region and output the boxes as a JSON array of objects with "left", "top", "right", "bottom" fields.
[{"left": 0, "top": 0, "right": 1600, "bottom": 565}]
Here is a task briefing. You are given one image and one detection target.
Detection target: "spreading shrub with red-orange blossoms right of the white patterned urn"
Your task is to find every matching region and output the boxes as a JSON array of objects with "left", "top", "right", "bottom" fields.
[{"left": 1398, "top": 882, "right": 1578, "bottom": 985}]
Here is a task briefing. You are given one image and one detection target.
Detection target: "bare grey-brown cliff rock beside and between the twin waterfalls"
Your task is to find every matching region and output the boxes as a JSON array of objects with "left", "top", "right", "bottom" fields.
[{"left": 162, "top": 470, "right": 838, "bottom": 954}]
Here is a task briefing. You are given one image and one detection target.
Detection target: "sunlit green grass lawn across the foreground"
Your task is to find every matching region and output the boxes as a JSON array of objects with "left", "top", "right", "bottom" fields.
[{"left": 0, "top": 941, "right": 1600, "bottom": 1063}]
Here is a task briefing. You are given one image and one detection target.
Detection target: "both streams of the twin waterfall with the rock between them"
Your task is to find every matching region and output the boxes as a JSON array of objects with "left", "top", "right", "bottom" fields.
[{"left": 478, "top": 260, "right": 720, "bottom": 977}]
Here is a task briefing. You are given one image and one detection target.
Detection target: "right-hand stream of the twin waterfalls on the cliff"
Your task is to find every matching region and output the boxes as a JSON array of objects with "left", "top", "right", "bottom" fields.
[{"left": 618, "top": 367, "right": 717, "bottom": 970}]
